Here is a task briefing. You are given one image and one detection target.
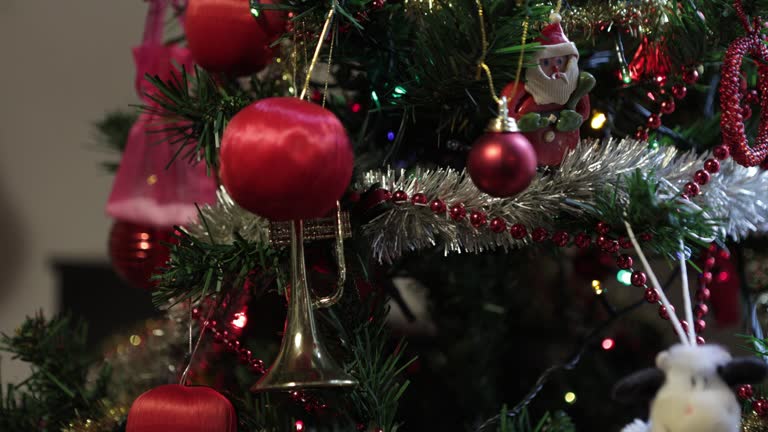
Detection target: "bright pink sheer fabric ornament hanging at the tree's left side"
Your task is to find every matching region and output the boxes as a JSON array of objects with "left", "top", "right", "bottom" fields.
[{"left": 106, "top": 0, "right": 216, "bottom": 227}]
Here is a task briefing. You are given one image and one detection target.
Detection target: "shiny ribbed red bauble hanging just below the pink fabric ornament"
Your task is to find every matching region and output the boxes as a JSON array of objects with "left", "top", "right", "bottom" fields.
[{"left": 109, "top": 220, "right": 173, "bottom": 289}]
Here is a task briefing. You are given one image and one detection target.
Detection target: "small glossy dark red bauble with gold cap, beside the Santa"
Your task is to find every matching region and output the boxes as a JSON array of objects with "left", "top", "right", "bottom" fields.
[{"left": 467, "top": 128, "right": 536, "bottom": 197}]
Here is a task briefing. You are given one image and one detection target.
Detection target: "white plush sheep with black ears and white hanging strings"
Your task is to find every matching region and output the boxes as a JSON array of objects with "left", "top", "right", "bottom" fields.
[{"left": 614, "top": 224, "right": 768, "bottom": 432}]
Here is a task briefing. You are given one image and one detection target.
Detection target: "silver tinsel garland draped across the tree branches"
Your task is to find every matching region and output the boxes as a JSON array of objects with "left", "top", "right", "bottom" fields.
[{"left": 188, "top": 139, "right": 768, "bottom": 262}]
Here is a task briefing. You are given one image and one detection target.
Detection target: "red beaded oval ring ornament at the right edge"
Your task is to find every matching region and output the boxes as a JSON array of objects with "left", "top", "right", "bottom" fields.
[{"left": 720, "top": 31, "right": 768, "bottom": 167}]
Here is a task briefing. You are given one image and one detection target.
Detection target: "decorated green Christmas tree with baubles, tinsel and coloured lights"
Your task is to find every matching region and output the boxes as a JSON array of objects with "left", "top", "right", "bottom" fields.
[{"left": 10, "top": 0, "right": 768, "bottom": 432}]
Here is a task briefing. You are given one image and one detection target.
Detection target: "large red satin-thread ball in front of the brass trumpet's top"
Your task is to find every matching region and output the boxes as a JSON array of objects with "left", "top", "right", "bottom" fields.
[{"left": 220, "top": 97, "right": 353, "bottom": 221}]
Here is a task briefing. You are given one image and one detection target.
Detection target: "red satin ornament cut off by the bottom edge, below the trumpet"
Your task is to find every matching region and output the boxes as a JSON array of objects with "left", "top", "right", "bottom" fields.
[{"left": 125, "top": 384, "right": 237, "bottom": 432}]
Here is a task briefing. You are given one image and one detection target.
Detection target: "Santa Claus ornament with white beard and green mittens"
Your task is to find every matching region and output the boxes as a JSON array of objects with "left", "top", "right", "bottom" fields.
[{"left": 502, "top": 13, "right": 595, "bottom": 166}]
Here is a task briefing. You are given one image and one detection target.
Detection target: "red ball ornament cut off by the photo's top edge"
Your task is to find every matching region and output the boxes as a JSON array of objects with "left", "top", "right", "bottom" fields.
[{"left": 185, "top": 0, "right": 278, "bottom": 76}]
